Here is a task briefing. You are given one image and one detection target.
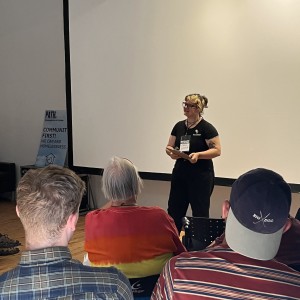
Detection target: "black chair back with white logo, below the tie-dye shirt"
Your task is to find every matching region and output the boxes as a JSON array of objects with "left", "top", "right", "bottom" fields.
[{"left": 129, "top": 274, "right": 159, "bottom": 300}]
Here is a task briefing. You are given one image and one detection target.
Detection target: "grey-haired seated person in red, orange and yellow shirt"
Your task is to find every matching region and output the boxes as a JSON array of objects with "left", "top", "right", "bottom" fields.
[{"left": 84, "top": 157, "right": 186, "bottom": 278}]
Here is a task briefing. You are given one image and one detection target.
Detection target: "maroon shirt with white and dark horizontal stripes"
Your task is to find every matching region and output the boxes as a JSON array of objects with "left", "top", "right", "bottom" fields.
[{"left": 151, "top": 245, "right": 300, "bottom": 300}]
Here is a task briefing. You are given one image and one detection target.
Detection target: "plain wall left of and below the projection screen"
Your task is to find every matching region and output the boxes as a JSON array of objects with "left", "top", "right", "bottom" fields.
[{"left": 0, "top": 0, "right": 300, "bottom": 217}]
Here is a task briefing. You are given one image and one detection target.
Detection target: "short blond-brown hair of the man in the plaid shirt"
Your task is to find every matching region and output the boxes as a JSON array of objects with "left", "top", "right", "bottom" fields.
[{"left": 16, "top": 165, "right": 85, "bottom": 239}]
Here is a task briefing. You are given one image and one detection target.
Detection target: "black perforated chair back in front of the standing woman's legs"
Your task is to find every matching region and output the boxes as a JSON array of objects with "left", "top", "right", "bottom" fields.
[{"left": 182, "top": 217, "right": 225, "bottom": 251}]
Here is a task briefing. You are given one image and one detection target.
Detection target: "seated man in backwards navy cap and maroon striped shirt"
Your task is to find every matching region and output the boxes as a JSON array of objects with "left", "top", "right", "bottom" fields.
[{"left": 151, "top": 169, "right": 300, "bottom": 300}]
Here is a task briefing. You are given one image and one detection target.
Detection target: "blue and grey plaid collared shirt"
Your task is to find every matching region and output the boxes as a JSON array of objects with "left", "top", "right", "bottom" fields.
[{"left": 0, "top": 247, "right": 133, "bottom": 300}]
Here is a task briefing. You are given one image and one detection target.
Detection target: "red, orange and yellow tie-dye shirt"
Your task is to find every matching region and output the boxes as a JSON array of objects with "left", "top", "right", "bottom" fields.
[{"left": 84, "top": 206, "right": 186, "bottom": 278}]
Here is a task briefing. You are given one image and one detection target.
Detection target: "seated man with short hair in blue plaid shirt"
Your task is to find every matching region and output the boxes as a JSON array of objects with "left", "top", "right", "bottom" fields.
[{"left": 0, "top": 166, "right": 133, "bottom": 300}]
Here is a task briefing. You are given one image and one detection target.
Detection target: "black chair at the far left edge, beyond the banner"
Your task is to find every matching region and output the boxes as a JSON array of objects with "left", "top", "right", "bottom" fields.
[{"left": 0, "top": 162, "right": 16, "bottom": 200}]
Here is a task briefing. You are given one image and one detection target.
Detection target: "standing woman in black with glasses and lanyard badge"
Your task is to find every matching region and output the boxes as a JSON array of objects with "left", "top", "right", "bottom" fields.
[{"left": 166, "top": 94, "right": 221, "bottom": 232}]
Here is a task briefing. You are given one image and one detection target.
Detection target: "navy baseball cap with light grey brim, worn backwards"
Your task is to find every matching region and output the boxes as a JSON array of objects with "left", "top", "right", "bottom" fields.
[{"left": 225, "top": 168, "right": 292, "bottom": 260}]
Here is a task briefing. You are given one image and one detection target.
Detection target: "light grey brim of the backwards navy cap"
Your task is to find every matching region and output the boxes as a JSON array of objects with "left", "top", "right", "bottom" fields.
[{"left": 225, "top": 209, "right": 283, "bottom": 260}]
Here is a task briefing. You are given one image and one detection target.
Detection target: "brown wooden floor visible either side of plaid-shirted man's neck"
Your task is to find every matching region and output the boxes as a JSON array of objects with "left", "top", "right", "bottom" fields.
[{"left": 0, "top": 200, "right": 85, "bottom": 274}]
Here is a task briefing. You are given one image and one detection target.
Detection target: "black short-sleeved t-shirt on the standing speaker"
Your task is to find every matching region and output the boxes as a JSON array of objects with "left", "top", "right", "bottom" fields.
[{"left": 171, "top": 119, "right": 219, "bottom": 170}]
